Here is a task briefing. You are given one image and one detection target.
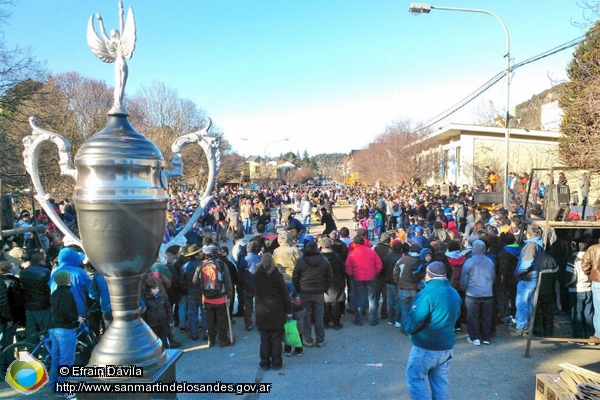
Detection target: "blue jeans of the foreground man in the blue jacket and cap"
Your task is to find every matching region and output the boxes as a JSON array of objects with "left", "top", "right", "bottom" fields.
[{"left": 406, "top": 346, "right": 454, "bottom": 400}]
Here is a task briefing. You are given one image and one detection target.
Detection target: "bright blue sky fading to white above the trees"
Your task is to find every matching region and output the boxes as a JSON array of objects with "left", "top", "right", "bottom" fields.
[{"left": 3, "top": 0, "right": 596, "bottom": 155}]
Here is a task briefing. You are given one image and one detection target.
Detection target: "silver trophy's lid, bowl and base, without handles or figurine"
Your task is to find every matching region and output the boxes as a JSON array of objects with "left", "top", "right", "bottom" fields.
[{"left": 73, "top": 115, "right": 168, "bottom": 374}]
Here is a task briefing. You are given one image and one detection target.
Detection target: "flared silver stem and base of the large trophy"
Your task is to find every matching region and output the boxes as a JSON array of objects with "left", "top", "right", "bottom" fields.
[{"left": 89, "top": 275, "right": 167, "bottom": 377}]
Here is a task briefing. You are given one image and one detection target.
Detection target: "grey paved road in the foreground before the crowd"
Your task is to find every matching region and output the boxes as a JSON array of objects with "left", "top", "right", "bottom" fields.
[{"left": 0, "top": 207, "right": 600, "bottom": 400}]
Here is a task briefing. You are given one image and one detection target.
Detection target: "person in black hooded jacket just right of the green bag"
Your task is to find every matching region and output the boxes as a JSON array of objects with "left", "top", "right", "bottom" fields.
[{"left": 292, "top": 242, "right": 333, "bottom": 347}]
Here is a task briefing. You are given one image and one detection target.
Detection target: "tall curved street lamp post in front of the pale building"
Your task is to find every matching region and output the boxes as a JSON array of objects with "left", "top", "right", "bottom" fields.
[{"left": 408, "top": 3, "right": 511, "bottom": 208}]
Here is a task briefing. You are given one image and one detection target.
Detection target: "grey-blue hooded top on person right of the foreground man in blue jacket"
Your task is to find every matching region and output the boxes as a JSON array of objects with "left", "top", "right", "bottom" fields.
[{"left": 460, "top": 240, "right": 496, "bottom": 297}]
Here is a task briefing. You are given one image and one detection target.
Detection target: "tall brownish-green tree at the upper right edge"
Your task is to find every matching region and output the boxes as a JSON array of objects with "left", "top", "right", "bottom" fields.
[{"left": 559, "top": 21, "right": 600, "bottom": 170}]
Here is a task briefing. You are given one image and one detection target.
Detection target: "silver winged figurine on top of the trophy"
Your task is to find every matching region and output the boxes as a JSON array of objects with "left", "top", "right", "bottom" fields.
[{"left": 87, "top": 1, "right": 136, "bottom": 115}]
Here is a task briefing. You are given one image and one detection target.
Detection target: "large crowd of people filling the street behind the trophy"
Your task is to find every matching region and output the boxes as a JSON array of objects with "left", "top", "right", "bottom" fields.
[{"left": 0, "top": 177, "right": 600, "bottom": 398}]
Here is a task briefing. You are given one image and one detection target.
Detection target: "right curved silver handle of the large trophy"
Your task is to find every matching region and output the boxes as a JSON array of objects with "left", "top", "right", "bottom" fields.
[{"left": 158, "top": 118, "right": 221, "bottom": 262}]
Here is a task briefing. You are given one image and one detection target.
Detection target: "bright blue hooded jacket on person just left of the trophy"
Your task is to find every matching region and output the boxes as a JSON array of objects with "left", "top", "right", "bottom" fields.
[{"left": 48, "top": 247, "right": 92, "bottom": 317}]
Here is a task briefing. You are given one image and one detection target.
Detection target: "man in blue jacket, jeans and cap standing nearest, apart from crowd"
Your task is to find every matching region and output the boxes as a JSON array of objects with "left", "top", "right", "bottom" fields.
[{"left": 404, "top": 261, "right": 462, "bottom": 400}]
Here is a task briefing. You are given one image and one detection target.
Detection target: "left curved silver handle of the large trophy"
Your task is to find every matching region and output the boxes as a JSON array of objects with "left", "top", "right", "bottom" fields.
[{"left": 23, "top": 117, "right": 83, "bottom": 248}]
